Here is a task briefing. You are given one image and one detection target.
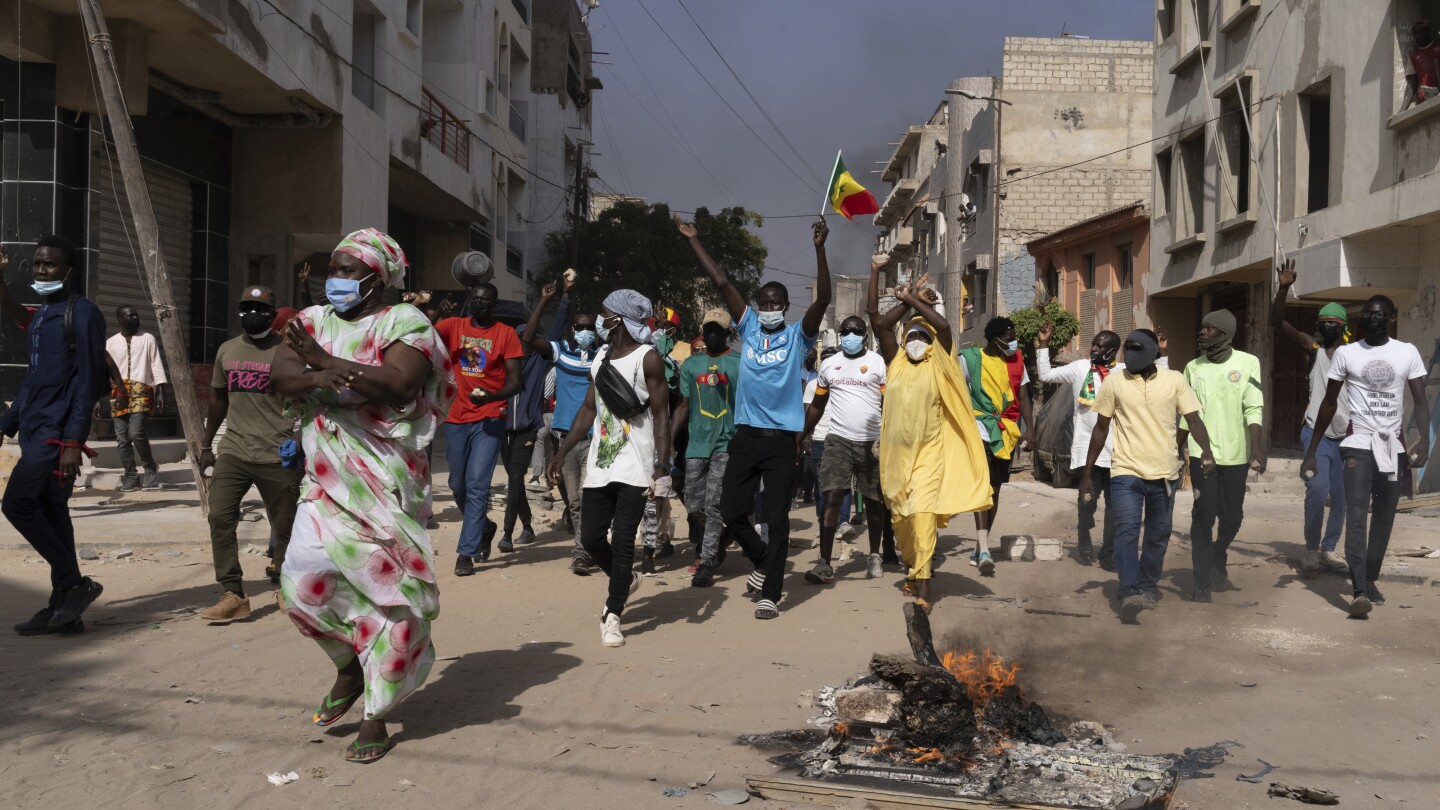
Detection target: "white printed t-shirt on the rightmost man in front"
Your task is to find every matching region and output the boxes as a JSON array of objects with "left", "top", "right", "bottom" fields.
[{"left": 1331, "top": 337, "right": 1427, "bottom": 450}]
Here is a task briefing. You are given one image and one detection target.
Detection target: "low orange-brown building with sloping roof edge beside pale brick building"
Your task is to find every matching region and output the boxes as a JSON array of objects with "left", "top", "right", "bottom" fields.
[{"left": 1025, "top": 202, "right": 1152, "bottom": 353}]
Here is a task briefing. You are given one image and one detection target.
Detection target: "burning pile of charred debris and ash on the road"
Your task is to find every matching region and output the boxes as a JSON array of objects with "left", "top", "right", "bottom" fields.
[{"left": 798, "top": 605, "right": 1178, "bottom": 810}]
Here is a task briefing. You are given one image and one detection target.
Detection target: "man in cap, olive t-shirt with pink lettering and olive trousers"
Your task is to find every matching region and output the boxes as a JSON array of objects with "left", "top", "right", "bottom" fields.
[{"left": 200, "top": 285, "right": 302, "bottom": 624}]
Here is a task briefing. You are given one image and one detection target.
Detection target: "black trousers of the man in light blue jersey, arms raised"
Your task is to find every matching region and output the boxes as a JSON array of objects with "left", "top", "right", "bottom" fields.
[{"left": 720, "top": 425, "right": 796, "bottom": 602}]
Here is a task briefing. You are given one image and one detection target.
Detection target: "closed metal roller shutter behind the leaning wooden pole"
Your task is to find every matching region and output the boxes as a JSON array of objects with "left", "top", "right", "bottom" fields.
[{"left": 91, "top": 146, "right": 194, "bottom": 337}]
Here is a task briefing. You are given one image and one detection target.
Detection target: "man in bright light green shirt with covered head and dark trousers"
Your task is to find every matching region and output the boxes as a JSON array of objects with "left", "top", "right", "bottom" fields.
[{"left": 1181, "top": 310, "right": 1266, "bottom": 602}]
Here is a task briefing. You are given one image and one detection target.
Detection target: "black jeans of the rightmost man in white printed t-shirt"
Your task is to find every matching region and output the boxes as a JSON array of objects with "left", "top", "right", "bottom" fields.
[{"left": 1341, "top": 447, "right": 1408, "bottom": 594}]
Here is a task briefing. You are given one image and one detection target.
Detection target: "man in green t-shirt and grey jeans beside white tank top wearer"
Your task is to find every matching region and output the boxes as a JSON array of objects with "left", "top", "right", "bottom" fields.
[{"left": 670, "top": 308, "right": 740, "bottom": 588}]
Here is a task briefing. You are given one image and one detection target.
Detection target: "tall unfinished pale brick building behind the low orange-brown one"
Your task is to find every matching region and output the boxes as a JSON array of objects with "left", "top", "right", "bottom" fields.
[{"left": 943, "top": 37, "right": 1153, "bottom": 343}]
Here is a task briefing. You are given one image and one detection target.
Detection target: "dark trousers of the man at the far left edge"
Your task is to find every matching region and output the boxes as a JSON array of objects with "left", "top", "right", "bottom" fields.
[{"left": 0, "top": 441, "right": 82, "bottom": 608}]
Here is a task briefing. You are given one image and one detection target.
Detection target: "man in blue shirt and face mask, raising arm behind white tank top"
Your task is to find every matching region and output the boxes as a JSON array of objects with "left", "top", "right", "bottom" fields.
[{"left": 520, "top": 274, "right": 598, "bottom": 577}]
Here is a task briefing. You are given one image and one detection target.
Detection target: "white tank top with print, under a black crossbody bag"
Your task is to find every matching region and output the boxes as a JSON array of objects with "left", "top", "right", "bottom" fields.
[{"left": 585, "top": 340, "right": 655, "bottom": 489}]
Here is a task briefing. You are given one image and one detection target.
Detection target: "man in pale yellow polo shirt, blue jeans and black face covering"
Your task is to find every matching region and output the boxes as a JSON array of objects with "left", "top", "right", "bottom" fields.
[{"left": 1080, "top": 329, "right": 1215, "bottom": 624}]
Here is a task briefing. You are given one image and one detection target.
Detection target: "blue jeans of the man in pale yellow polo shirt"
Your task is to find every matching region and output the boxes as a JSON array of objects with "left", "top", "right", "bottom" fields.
[{"left": 1106, "top": 476, "right": 1175, "bottom": 600}]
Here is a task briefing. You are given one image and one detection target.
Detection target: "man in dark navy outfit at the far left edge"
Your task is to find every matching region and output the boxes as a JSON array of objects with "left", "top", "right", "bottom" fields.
[{"left": 0, "top": 236, "right": 108, "bottom": 636}]
